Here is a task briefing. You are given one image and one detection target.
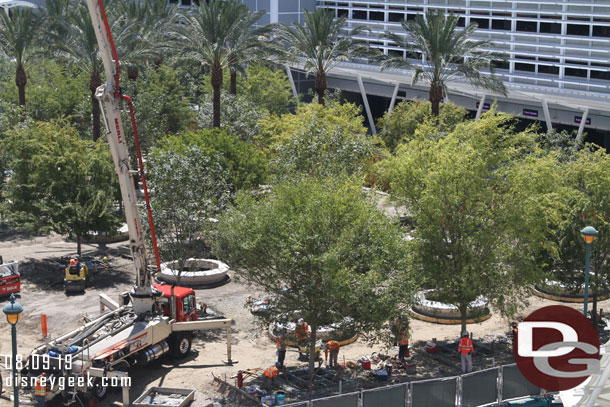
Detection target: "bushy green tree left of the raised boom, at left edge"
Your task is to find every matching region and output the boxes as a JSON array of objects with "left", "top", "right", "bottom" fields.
[{"left": 2, "top": 121, "right": 118, "bottom": 255}]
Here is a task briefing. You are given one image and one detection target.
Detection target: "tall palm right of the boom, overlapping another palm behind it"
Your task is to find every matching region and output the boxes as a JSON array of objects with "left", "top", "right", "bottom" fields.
[{"left": 173, "top": 0, "right": 257, "bottom": 127}]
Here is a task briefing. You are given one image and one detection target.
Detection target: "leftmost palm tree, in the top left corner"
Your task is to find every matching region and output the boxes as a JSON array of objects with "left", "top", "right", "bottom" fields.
[{"left": 0, "top": 7, "right": 39, "bottom": 106}]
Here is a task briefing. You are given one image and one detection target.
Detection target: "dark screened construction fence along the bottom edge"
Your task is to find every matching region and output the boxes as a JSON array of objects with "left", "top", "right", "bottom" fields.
[{"left": 278, "top": 364, "right": 543, "bottom": 407}]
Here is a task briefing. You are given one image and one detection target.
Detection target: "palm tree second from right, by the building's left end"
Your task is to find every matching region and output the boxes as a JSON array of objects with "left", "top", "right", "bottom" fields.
[{"left": 279, "top": 9, "right": 369, "bottom": 105}]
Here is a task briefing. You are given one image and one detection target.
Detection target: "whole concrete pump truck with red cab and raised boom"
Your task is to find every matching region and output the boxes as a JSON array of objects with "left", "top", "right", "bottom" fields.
[{"left": 21, "top": 0, "right": 232, "bottom": 406}]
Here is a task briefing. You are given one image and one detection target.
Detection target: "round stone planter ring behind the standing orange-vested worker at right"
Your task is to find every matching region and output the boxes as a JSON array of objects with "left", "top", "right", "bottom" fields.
[{"left": 411, "top": 290, "right": 491, "bottom": 325}]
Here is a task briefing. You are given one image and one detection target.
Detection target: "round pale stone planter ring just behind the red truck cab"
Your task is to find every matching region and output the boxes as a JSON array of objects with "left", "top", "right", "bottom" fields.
[{"left": 157, "top": 259, "right": 230, "bottom": 286}]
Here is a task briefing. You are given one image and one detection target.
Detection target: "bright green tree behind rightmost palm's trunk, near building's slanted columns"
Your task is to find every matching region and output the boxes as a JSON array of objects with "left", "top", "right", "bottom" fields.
[{"left": 377, "top": 100, "right": 468, "bottom": 152}]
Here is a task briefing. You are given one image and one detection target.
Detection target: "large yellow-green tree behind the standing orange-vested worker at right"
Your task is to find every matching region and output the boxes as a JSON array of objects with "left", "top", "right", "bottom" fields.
[{"left": 380, "top": 113, "right": 548, "bottom": 330}]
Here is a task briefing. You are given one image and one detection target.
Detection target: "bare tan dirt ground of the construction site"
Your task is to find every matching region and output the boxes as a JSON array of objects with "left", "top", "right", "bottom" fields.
[{"left": 0, "top": 231, "right": 610, "bottom": 407}]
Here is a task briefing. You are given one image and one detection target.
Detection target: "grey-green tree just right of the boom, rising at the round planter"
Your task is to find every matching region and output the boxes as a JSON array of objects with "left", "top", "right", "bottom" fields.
[{"left": 148, "top": 146, "right": 232, "bottom": 279}]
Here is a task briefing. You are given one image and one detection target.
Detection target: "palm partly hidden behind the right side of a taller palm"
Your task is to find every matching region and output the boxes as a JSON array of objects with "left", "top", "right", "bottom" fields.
[{"left": 228, "top": 5, "right": 278, "bottom": 95}]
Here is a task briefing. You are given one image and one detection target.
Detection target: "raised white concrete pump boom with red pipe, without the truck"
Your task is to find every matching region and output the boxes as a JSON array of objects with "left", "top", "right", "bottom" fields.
[{"left": 86, "top": 0, "right": 160, "bottom": 315}]
